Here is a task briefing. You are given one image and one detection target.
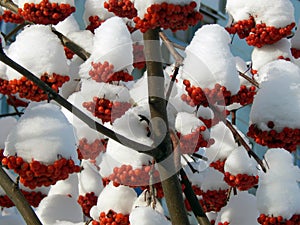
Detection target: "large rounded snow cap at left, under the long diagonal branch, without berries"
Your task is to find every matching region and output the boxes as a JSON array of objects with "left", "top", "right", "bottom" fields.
[{"left": 4, "top": 103, "right": 78, "bottom": 164}]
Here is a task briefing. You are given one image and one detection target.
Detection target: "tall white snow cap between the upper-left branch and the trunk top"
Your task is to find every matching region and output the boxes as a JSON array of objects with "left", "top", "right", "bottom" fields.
[{"left": 79, "top": 17, "right": 133, "bottom": 78}]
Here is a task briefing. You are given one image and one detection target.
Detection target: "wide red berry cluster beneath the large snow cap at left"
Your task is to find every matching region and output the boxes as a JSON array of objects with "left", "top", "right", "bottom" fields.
[{"left": 1, "top": 156, "right": 80, "bottom": 189}]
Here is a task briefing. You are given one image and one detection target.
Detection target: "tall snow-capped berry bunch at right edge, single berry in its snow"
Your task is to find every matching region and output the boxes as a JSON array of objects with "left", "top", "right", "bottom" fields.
[{"left": 247, "top": 60, "right": 300, "bottom": 151}]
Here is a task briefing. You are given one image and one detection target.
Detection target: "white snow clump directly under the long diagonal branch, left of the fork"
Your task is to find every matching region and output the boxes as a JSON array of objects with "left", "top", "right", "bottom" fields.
[{"left": 99, "top": 139, "right": 152, "bottom": 177}]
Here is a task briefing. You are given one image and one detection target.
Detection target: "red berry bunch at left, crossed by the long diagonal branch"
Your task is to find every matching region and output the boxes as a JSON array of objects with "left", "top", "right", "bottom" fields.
[{"left": 9, "top": 73, "right": 70, "bottom": 102}]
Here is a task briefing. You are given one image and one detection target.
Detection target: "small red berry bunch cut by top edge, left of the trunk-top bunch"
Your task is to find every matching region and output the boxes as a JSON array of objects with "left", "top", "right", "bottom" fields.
[{"left": 104, "top": 0, "right": 137, "bottom": 19}]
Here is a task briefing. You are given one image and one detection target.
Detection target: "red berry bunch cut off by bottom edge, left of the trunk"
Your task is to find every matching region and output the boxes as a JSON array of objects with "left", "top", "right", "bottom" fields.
[{"left": 92, "top": 210, "right": 130, "bottom": 225}]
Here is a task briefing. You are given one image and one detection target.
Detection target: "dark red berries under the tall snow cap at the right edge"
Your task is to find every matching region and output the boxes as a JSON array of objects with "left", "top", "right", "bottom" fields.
[{"left": 247, "top": 121, "right": 300, "bottom": 152}]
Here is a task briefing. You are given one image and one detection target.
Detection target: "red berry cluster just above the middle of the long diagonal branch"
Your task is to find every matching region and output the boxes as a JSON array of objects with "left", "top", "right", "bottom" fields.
[{"left": 82, "top": 97, "right": 131, "bottom": 123}]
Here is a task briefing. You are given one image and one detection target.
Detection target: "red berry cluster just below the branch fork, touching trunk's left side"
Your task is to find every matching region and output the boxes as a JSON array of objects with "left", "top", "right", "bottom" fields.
[{"left": 107, "top": 165, "right": 159, "bottom": 187}]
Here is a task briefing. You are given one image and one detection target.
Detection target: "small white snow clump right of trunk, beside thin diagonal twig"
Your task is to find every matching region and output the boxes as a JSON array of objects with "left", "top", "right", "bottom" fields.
[{"left": 205, "top": 122, "right": 238, "bottom": 163}]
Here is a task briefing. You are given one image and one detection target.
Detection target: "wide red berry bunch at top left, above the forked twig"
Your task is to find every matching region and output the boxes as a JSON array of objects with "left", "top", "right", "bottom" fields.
[{"left": 18, "top": 0, "right": 75, "bottom": 25}]
